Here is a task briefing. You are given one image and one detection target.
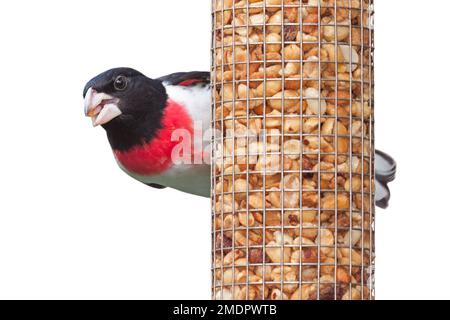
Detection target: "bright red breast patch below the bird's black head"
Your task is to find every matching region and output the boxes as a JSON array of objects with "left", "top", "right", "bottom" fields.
[{"left": 114, "top": 100, "right": 193, "bottom": 175}]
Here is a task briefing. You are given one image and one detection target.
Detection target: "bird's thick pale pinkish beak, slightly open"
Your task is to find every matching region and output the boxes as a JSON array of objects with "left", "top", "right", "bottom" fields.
[{"left": 84, "top": 88, "right": 122, "bottom": 127}]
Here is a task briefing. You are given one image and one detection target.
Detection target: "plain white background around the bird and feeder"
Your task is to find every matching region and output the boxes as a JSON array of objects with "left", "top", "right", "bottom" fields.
[{"left": 0, "top": 0, "right": 450, "bottom": 299}]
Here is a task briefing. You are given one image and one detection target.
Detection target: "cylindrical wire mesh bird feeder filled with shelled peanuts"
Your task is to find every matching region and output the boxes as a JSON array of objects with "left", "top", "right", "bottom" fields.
[{"left": 212, "top": 0, "right": 375, "bottom": 300}]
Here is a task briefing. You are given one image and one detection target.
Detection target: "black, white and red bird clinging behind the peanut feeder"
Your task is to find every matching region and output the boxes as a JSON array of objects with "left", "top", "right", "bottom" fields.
[{"left": 83, "top": 68, "right": 396, "bottom": 208}]
